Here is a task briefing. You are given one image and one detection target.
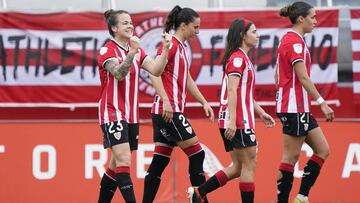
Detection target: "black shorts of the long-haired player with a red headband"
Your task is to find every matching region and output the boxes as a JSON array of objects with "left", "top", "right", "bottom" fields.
[{"left": 219, "top": 128, "right": 257, "bottom": 152}]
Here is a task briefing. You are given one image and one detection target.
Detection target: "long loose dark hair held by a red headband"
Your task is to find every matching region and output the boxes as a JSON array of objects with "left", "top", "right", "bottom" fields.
[{"left": 222, "top": 18, "right": 253, "bottom": 71}]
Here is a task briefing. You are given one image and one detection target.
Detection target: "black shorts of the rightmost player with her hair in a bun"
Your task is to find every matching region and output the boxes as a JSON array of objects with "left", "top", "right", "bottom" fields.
[{"left": 277, "top": 112, "right": 319, "bottom": 137}]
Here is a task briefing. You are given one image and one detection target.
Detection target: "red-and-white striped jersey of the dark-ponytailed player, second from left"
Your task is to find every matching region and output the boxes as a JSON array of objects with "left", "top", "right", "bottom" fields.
[{"left": 151, "top": 36, "right": 189, "bottom": 114}]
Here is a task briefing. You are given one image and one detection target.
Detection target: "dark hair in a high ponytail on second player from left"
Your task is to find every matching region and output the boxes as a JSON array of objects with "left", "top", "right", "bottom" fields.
[{"left": 164, "top": 5, "right": 200, "bottom": 32}]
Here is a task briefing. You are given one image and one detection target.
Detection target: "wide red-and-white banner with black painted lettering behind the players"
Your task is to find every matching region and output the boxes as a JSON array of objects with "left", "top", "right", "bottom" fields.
[{"left": 0, "top": 10, "right": 339, "bottom": 107}]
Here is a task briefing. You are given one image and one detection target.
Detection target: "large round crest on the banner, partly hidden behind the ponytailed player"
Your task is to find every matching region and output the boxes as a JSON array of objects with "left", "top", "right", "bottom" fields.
[{"left": 134, "top": 15, "right": 203, "bottom": 96}]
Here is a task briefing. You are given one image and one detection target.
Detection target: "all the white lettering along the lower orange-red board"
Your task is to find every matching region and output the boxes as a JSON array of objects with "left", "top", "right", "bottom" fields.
[{"left": 20, "top": 143, "right": 360, "bottom": 180}]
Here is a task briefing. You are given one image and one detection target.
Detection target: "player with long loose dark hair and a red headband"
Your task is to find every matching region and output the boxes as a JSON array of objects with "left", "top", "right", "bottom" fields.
[{"left": 188, "top": 18, "right": 275, "bottom": 203}]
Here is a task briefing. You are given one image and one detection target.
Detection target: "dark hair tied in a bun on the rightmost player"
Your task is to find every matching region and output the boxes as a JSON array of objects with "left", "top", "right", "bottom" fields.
[{"left": 279, "top": 1, "right": 313, "bottom": 24}]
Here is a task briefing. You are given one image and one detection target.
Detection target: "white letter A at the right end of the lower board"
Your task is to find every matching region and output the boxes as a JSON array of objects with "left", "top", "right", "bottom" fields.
[{"left": 341, "top": 143, "right": 360, "bottom": 178}]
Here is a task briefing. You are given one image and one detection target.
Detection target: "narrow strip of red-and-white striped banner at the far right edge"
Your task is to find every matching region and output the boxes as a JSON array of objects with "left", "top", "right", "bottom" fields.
[{"left": 350, "top": 9, "right": 360, "bottom": 103}]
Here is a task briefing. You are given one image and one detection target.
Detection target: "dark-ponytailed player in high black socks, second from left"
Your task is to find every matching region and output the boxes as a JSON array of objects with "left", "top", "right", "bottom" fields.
[{"left": 143, "top": 6, "right": 214, "bottom": 203}]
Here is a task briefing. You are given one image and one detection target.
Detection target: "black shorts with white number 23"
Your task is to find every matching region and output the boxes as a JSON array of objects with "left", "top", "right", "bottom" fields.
[{"left": 101, "top": 121, "right": 139, "bottom": 150}]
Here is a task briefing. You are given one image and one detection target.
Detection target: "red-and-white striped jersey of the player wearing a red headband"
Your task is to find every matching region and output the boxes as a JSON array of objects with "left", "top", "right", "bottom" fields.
[{"left": 219, "top": 49, "right": 255, "bottom": 129}]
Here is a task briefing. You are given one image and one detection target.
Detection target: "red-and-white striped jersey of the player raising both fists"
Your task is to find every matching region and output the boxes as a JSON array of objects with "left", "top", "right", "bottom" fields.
[{"left": 97, "top": 40, "right": 147, "bottom": 124}]
